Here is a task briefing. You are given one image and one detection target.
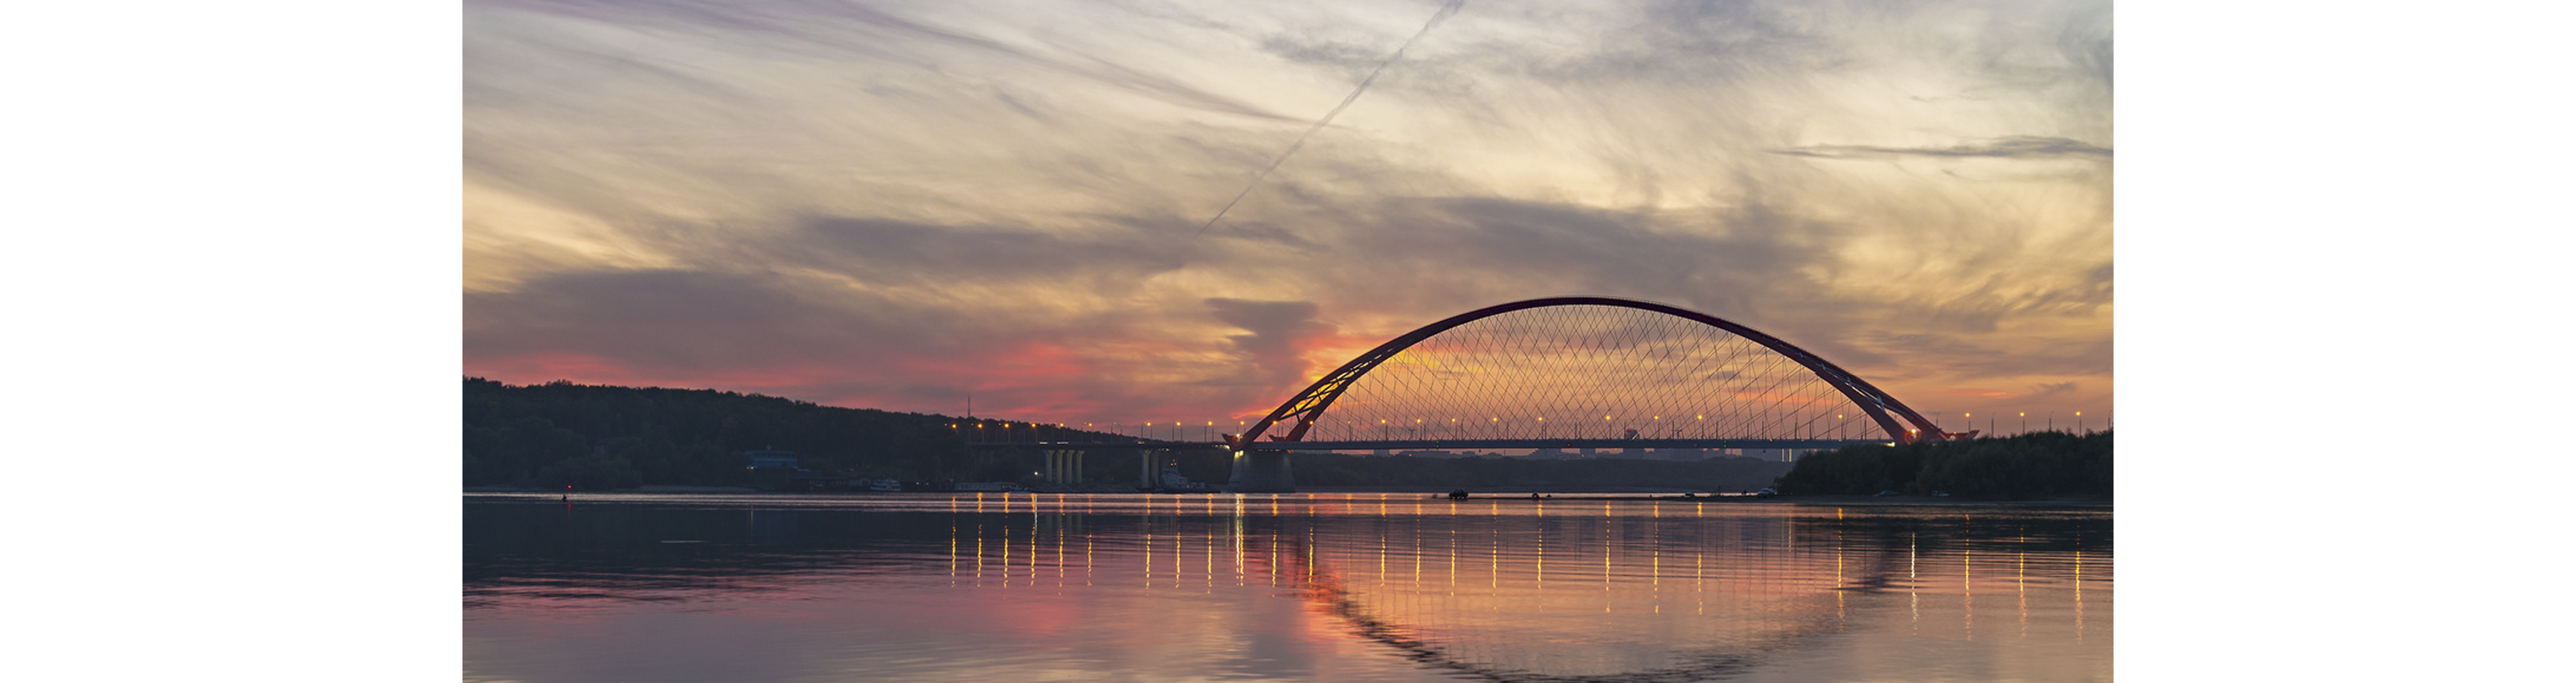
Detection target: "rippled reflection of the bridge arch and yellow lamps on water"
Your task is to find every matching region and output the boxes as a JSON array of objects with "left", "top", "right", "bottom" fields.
[{"left": 950, "top": 495, "right": 2107, "bottom": 680}]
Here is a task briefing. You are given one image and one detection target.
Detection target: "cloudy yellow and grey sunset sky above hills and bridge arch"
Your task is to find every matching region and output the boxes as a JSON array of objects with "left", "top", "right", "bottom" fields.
[{"left": 464, "top": 0, "right": 2115, "bottom": 433}]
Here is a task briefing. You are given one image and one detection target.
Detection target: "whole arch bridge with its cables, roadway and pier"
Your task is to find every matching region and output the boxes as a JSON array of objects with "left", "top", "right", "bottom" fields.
[{"left": 976, "top": 296, "right": 1976, "bottom": 492}]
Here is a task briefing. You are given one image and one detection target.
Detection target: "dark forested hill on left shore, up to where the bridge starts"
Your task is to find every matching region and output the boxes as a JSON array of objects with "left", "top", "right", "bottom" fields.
[{"left": 464, "top": 376, "right": 966, "bottom": 490}]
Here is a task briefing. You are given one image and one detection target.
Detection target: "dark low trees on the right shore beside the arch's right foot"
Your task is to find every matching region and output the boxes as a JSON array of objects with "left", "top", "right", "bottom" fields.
[{"left": 1780, "top": 430, "right": 2110, "bottom": 500}]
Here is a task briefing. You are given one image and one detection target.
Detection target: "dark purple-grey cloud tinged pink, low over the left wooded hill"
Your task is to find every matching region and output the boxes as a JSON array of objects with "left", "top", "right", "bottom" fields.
[{"left": 466, "top": 271, "right": 1190, "bottom": 420}]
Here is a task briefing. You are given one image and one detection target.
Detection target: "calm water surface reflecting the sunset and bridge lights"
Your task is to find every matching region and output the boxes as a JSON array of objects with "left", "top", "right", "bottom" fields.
[{"left": 464, "top": 492, "right": 2112, "bottom": 683}]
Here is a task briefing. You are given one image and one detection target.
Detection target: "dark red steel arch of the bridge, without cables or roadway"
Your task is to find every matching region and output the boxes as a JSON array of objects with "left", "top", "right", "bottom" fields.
[{"left": 1226, "top": 296, "right": 1963, "bottom": 451}]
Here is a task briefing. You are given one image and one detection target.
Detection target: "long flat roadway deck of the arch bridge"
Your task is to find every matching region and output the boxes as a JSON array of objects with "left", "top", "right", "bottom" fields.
[{"left": 966, "top": 438, "right": 1891, "bottom": 451}]
